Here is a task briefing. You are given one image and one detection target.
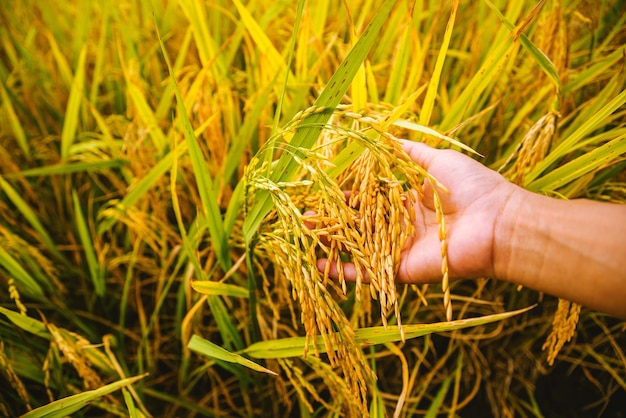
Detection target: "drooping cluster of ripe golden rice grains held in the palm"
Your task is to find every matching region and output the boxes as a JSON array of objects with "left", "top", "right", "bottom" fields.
[{"left": 241, "top": 107, "right": 449, "bottom": 413}]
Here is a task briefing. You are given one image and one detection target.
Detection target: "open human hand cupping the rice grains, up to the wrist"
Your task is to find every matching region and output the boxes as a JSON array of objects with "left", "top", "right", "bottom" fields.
[{"left": 318, "top": 141, "right": 521, "bottom": 283}]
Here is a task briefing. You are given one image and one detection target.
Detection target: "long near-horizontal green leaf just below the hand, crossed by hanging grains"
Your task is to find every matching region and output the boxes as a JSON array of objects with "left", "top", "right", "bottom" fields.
[{"left": 243, "top": 306, "right": 534, "bottom": 359}]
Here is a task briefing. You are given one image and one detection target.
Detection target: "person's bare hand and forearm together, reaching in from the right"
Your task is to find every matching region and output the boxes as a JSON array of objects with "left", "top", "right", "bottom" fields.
[{"left": 318, "top": 141, "right": 626, "bottom": 319}]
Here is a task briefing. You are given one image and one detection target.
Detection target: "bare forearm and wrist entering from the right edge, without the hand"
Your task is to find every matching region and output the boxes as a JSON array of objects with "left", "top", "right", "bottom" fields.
[{"left": 493, "top": 189, "right": 626, "bottom": 319}]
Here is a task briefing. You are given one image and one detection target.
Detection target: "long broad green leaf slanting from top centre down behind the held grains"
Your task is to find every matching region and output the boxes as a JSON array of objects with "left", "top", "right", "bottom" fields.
[{"left": 243, "top": 0, "right": 395, "bottom": 242}]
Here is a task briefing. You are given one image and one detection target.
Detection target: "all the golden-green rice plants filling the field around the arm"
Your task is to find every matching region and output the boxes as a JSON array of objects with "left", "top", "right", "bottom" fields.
[{"left": 0, "top": 0, "right": 626, "bottom": 417}]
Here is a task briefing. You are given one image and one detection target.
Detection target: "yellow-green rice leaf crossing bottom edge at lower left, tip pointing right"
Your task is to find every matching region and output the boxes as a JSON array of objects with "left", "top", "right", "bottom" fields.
[{"left": 22, "top": 373, "right": 148, "bottom": 418}]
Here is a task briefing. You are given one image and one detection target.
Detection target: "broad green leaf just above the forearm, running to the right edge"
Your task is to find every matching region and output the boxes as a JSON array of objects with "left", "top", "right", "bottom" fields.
[{"left": 527, "top": 135, "right": 626, "bottom": 192}]
